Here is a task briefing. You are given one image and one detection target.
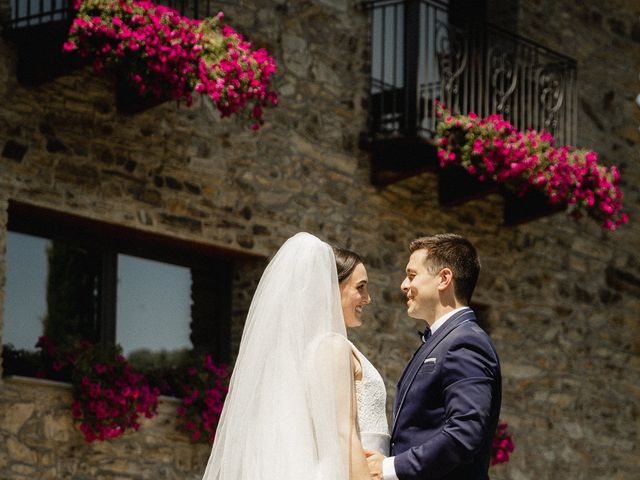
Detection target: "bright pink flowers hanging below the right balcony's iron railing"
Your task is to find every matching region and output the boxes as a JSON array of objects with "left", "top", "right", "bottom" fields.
[{"left": 437, "top": 105, "right": 629, "bottom": 230}]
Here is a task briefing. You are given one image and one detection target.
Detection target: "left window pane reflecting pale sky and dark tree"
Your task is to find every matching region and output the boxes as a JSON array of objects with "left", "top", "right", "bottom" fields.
[{"left": 3, "top": 232, "right": 99, "bottom": 350}]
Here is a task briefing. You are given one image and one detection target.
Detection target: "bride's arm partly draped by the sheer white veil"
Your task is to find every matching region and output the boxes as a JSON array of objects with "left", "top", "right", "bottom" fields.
[{"left": 310, "top": 334, "right": 371, "bottom": 480}]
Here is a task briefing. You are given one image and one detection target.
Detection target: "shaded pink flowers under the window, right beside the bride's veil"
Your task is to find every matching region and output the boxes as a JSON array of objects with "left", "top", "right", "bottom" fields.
[{"left": 176, "top": 353, "right": 229, "bottom": 443}]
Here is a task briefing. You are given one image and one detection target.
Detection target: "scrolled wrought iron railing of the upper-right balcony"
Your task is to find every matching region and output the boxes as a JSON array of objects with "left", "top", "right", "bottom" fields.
[{"left": 365, "top": 0, "right": 577, "bottom": 144}]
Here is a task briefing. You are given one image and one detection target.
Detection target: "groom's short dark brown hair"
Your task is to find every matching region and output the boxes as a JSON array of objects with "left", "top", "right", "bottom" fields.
[{"left": 409, "top": 233, "right": 480, "bottom": 305}]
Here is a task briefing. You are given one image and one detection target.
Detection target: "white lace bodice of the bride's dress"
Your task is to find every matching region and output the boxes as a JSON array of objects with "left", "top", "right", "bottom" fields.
[{"left": 353, "top": 346, "right": 390, "bottom": 454}]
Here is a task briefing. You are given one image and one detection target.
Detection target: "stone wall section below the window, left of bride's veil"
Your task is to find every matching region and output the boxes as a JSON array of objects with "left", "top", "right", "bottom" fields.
[{"left": 0, "top": 379, "right": 210, "bottom": 480}]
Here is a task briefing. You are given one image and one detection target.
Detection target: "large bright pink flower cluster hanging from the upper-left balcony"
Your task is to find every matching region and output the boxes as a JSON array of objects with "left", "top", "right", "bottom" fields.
[{"left": 63, "top": 0, "right": 277, "bottom": 130}]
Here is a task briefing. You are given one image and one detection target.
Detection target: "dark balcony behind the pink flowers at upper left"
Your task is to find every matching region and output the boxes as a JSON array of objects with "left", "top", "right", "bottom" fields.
[{"left": 3, "top": 0, "right": 222, "bottom": 87}]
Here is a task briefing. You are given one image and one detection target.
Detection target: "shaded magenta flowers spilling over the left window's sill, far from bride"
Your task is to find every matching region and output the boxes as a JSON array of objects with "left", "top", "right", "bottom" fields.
[{"left": 36, "top": 337, "right": 160, "bottom": 442}]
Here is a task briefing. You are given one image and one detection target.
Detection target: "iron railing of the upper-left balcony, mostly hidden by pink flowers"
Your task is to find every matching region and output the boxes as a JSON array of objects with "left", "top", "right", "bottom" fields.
[{"left": 8, "top": 0, "right": 224, "bottom": 29}]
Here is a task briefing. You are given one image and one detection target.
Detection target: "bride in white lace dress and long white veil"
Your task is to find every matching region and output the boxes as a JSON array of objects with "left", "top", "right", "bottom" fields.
[{"left": 203, "top": 233, "right": 389, "bottom": 480}]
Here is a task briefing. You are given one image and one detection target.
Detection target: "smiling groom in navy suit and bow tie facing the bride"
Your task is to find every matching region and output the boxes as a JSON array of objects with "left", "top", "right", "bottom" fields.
[{"left": 367, "top": 234, "right": 501, "bottom": 480}]
